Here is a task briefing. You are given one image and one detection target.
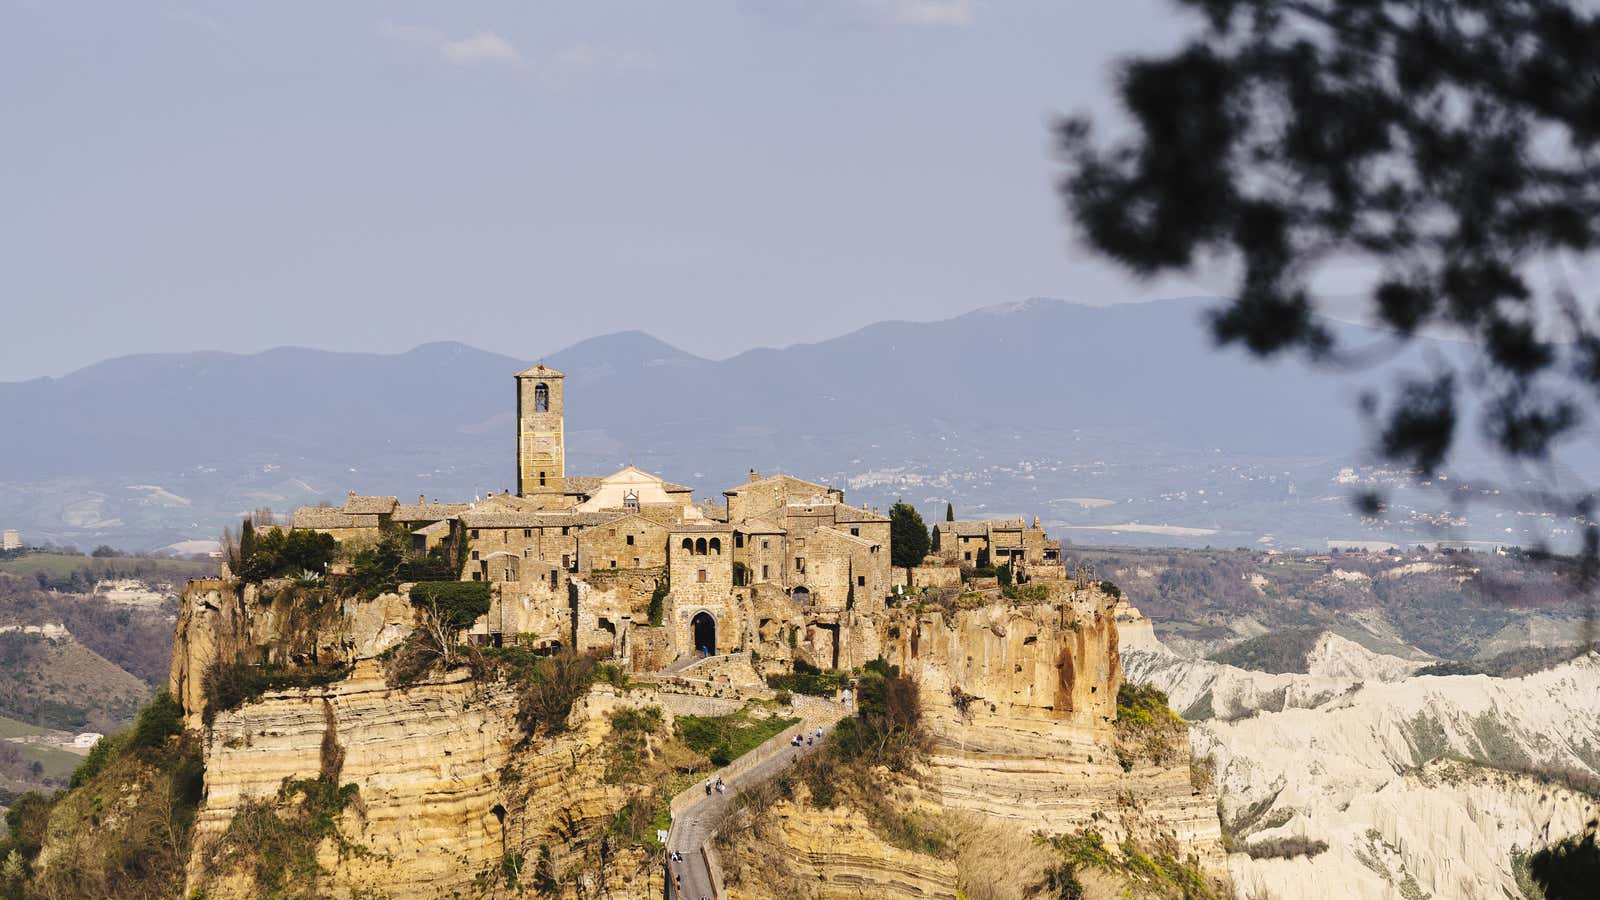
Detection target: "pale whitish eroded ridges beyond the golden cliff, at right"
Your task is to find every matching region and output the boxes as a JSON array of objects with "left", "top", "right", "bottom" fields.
[{"left": 1123, "top": 637, "right": 1600, "bottom": 900}]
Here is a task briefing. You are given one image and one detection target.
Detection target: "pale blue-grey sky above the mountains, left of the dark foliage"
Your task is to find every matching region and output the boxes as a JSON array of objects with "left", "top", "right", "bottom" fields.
[{"left": 0, "top": 0, "right": 1203, "bottom": 380}]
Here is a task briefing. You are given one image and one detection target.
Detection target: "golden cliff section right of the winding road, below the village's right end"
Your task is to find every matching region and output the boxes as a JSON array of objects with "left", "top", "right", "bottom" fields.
[{"left": 725, "top": 586, "right": 1226, "bottom": 898}]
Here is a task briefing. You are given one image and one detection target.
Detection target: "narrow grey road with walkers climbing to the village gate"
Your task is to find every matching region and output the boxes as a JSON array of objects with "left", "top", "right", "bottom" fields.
[{"left": 667, "top": 700, "right": 850, "bottom": 900}]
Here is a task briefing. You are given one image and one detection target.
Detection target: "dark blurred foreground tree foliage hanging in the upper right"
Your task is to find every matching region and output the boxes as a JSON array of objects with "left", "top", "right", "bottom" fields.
[{"left": 1058, "top": 0, "right": 1600, "bottom": 588}]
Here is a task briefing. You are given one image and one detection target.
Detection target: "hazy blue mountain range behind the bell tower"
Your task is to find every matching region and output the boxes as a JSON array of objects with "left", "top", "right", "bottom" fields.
[{"left": 0, "top": 299, "right": 1548, "bottom": 548}]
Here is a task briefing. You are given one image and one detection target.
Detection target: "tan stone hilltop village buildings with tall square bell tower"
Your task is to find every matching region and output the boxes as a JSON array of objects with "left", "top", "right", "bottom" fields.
[{"left": 293, "top": 364, "right": 1061, "bottom": 669}]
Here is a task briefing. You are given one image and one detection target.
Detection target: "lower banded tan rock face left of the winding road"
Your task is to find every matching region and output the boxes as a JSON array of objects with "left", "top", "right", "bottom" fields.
[{"left": 189, "top": 661, "right": 665, "bottom": 898}]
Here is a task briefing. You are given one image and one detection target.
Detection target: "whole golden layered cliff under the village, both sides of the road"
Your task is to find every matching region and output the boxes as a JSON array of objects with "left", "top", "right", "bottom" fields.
[{"left": 15, "top": 570, "right": 1222, "bottom": 900}]
